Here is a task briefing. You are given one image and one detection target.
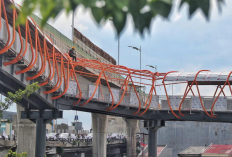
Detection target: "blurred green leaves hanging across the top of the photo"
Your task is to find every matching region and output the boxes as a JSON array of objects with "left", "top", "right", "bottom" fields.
[{"left": 19, "top": 0, "right": 224, "bottom": 35}]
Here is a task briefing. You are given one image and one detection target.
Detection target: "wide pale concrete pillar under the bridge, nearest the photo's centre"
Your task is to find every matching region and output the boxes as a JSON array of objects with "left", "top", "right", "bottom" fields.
[{"left": 92, "top": 113, "right": 108, "bottom": 157}]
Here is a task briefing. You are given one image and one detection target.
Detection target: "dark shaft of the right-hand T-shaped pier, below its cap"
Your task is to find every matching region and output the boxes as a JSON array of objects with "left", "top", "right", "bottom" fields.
[{"left": 148, "top": 127, "right": 160, "bottom": 157}]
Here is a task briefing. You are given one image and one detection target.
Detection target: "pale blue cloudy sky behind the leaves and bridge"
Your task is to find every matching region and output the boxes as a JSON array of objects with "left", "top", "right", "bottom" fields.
[{"left": 11, "top": 0, "right": 232, "bottom": 129}]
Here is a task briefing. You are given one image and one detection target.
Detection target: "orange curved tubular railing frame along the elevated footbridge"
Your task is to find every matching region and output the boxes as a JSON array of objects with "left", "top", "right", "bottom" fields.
[{"left": 0, "top": 0, "right": 232, "bottom": 119}]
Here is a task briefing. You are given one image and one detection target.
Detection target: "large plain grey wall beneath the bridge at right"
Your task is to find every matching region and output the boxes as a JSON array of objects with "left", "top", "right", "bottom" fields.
[{"left": 158, "top": 122, "right": 232, "bottom": 157}]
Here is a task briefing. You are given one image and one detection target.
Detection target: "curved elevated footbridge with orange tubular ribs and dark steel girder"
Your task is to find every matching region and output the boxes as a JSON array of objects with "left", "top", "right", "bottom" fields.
[{"left": 0, "top": 0, "right": 232, "bottom": 122}]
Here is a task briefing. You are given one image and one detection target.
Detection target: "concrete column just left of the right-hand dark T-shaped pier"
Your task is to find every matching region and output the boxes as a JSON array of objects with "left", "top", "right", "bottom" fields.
[{"left": 125, "top": 119, "right": 138, "bottom": 157}]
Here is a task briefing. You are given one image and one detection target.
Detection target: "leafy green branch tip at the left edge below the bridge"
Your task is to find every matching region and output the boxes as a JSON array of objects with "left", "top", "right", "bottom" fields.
[{"left": 0, "top": 82, "right": 40, "bottom": 118}]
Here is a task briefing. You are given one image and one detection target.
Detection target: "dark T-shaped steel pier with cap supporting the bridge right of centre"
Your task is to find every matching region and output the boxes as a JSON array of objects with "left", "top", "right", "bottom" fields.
[{"left": 144, "top": 120, "right": 165, "bottom": 157}]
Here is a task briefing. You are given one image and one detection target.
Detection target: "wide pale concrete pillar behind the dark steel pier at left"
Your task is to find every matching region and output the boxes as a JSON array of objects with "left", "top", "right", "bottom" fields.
[{"left": 17, "top": 105, "right": 36, "bottom": 157}]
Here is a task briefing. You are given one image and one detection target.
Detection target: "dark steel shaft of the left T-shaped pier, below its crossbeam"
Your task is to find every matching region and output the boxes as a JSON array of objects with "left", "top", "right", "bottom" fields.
[{"left": 35, "top": 118, "right": 46, "bottom": 157}]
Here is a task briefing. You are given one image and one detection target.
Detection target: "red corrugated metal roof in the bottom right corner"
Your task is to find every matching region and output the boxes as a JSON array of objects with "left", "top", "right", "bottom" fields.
[{"left": 203, "top": 145, "right": 232, "bottom": 154}]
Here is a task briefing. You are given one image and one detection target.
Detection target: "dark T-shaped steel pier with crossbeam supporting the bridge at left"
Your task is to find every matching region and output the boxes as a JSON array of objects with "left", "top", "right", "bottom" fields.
[{"left": 18, "top": 110, "right": 63, "bottom": 157}]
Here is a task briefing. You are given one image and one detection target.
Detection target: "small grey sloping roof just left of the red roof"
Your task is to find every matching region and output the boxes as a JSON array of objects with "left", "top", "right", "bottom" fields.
[{"left": 178, "top": 146, "right": 208, "bottom": 157}]
